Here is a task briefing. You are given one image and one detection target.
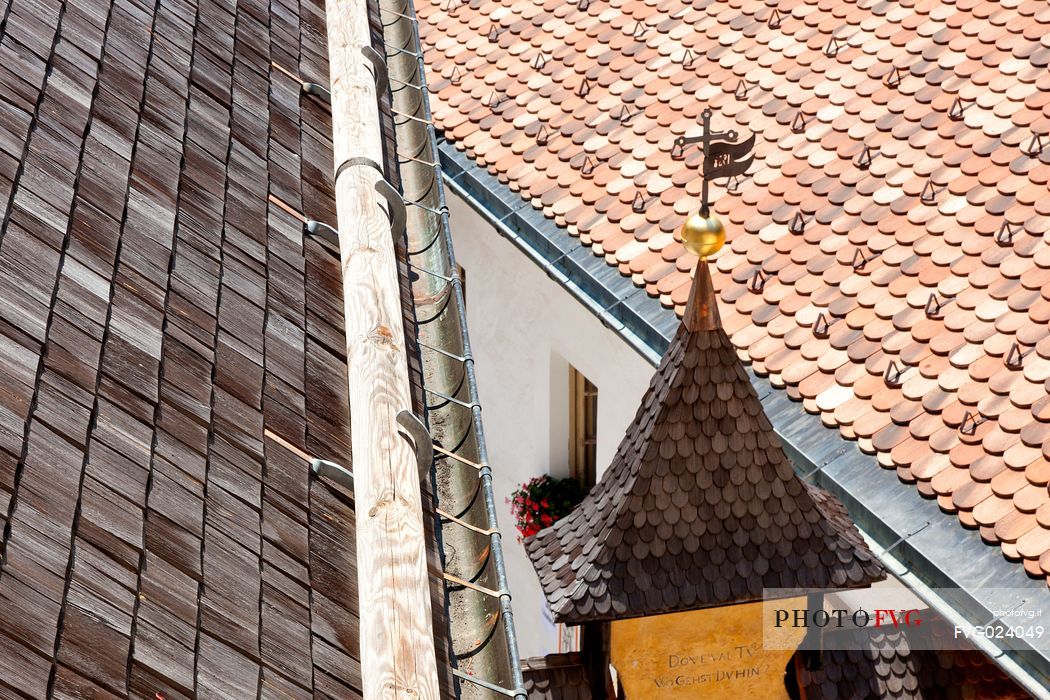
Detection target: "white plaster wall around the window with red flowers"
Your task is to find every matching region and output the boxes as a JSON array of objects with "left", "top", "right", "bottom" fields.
[{"left": 446, "top": 191, "right": 654, "bottom": 657}]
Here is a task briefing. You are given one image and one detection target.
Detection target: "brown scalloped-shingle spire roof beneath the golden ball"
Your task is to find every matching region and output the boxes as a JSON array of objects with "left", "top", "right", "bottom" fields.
[{"left": 525, "top": 228, "right": 884, "bottom": 623}]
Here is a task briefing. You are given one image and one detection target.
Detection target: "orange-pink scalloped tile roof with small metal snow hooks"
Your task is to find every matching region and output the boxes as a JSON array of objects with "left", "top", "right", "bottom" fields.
[{"left": 419, "top": 0, "right": 1050, "bottom": 576}]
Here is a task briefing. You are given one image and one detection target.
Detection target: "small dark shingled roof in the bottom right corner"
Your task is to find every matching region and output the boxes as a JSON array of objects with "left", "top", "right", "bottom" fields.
[{"left": 797, "top": 618, "right": 1031, "bottom": 700}]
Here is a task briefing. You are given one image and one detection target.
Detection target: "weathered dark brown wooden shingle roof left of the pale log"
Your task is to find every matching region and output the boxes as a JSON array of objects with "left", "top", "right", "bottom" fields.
[{"left": 0, "top": 0, "right": 448, "bottom": 700}]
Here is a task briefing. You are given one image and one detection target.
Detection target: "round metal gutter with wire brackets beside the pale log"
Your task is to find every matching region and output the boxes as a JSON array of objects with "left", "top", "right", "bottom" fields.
[{"left": 376, "top": 0, "right": 526, "bottom": 700}]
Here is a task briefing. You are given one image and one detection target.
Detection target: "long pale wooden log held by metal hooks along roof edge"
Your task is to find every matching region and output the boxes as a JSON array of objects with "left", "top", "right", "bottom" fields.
[{"left": 326, "top": 0, "right": 439, "bottom": 700}]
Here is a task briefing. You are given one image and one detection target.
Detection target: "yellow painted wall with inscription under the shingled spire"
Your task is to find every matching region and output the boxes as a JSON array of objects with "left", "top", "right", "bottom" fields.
[{"left": 610, "top": 598, "right": 805, "bottom": 700}]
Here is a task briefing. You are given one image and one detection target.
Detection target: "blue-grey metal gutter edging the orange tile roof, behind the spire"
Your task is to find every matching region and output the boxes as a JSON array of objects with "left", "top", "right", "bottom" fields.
[{"left": 438, "top": 140, "right": 1050, "bottom": 697}]
